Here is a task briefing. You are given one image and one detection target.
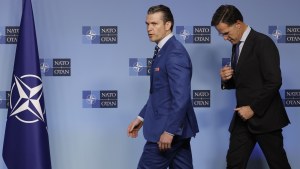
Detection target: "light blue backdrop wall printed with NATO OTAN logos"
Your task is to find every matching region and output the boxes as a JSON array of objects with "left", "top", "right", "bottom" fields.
[{"left": 0, "top": 0, "right": 300, "bottom": 169}]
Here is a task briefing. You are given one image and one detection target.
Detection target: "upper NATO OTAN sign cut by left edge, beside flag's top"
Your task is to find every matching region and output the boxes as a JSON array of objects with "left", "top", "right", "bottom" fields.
[{"left": 0, "top": 26, "right": 20, "bottom": 44}]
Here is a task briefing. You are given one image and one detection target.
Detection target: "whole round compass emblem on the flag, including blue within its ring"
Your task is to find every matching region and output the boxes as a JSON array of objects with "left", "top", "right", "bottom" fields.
[{"left": 9, "top": 74, "right": 45, "bottom": 123}]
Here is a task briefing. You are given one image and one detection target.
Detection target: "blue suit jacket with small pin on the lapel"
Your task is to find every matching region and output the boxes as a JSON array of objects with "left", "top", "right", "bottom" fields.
[{"left": 139, "top": 36, "right": 199, "bottom": 142}]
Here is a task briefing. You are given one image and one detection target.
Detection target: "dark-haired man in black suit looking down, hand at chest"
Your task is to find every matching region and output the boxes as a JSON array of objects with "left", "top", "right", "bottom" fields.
[{"left": 211, "top": 5, "right": 291, "bottom": 169}]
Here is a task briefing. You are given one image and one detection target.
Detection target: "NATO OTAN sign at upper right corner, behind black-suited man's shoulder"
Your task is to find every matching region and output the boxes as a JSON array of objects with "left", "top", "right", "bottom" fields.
[{"left": 268, "top": 26, "right": 300, "bottom": 43}]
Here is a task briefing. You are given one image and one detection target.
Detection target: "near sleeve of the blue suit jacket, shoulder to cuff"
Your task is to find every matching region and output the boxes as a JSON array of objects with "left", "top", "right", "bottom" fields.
[{"left": 166, "top": 50, "right": 192, "bottom": 135}]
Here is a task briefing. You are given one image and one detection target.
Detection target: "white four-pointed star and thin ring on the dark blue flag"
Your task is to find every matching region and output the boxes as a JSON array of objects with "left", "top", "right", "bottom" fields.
[{"left": 9, "top": 75, "right": 45, "bottom": 123}]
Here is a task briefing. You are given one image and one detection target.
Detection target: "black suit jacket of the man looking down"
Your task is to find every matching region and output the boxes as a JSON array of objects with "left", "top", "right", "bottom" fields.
[{"left": 222, "top": 29, "right": 290, "bottom": 133}]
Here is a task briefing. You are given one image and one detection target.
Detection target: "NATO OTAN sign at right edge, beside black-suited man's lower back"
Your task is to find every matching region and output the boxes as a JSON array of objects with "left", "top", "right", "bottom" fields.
[{"left": 283, "top": 89, "right": 300, "bottom": 107}]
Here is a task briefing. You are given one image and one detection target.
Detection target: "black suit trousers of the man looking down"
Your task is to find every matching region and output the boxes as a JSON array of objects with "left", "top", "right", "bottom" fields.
[{"left": 226, "top": 117, "right": 291, "bottom": 169}]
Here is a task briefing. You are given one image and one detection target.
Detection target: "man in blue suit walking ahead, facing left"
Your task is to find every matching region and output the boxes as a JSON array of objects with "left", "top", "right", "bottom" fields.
[{"left": 127, "top": 5, "right": 198, "bottom": 169}]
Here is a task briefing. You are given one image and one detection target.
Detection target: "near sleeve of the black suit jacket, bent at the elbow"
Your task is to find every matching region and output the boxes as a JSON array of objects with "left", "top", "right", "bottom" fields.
[{"left": 250, "top": 37, "right": 282, "bottom": 116}]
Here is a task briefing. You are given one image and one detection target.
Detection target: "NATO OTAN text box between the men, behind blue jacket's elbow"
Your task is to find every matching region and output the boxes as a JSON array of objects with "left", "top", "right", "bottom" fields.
[{"left": 192, "top": 90, "right": 210, "bottom": 107}]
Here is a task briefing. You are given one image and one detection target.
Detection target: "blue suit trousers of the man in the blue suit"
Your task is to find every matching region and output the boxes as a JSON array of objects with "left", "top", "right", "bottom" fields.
[{"left": 137, "top": 136, "right": 193, "bottom": 169}]
